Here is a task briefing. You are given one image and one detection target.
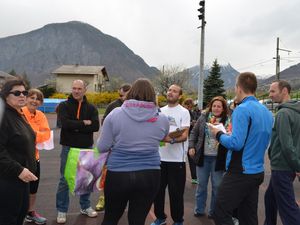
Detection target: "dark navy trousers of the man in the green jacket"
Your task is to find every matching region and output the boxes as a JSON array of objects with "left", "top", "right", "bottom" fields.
[{"left": 264, "top": 170, "right": 300, "bottom": 225}]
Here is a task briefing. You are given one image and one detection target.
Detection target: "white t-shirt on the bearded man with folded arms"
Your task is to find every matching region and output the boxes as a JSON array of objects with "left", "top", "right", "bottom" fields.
[{"left": 159, "top": 104, "right": 190, "bottom": 162}]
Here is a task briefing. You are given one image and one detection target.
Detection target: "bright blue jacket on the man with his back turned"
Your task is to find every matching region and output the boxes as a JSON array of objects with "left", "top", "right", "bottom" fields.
[{"left": 217, "top": 96, "right": 273, "bottom": 174}]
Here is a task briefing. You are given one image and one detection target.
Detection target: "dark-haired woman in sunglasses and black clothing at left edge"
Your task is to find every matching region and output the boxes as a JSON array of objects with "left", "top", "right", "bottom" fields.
[{"left": 0, "top": 79, "right": 37, "bottom": 225}]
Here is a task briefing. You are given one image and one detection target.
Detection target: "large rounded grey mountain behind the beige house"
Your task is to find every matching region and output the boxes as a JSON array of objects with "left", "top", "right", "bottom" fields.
[{"left": 0, "top": 21, "right": 158, "bottom": 86}]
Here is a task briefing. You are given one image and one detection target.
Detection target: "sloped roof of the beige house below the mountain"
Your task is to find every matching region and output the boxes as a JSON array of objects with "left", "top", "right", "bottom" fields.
[{"left": 52, "top": 65, "right": 109, "bottom": 81}]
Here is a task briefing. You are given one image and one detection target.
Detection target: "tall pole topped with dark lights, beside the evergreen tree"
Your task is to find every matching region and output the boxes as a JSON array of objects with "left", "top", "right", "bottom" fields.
[{"left": 198, "top": 0, "right": 206, "bottom": 110}]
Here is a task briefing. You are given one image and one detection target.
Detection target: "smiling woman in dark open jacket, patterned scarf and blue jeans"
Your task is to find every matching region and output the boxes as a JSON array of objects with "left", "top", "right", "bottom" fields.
[{"left": 189, "top": 96, "right": 231, "bottom": 219}]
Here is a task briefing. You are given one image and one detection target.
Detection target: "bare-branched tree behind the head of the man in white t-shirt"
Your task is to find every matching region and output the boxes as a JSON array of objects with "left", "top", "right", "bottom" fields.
[{"left": 153, "top": 66, "right": 190, "bottom": 97}]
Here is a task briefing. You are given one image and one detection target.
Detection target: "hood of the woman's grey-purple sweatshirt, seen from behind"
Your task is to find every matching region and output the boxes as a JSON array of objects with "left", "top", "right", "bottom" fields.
[{"left": 121, "top": 99, "right": 158, "bottom": 122}]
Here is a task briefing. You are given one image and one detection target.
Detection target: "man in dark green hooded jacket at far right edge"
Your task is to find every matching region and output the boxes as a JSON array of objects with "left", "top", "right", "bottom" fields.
[{"left": 265, "top": 80, "right": 300, "bottom": 225}]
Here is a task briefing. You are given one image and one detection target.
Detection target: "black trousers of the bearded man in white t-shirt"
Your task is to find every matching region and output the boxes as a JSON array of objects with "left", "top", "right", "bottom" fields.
[{"left": 154, "top": 162, "right": 186, "bottom": 223}]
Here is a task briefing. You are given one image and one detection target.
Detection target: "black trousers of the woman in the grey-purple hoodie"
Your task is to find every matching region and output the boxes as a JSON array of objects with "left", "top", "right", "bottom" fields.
[{"left": 102, "top": 169, "right": 160, "bottom": 225}]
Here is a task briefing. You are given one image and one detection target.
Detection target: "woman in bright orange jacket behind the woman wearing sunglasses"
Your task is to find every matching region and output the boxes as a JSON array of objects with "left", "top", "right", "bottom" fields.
[{"left": 22, "top": 89, "right": 50, "bottom": 224}]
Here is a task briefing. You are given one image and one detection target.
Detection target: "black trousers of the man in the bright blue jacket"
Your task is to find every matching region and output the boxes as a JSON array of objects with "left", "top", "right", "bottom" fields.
[{"left": 213, "top": 173, "right": 264, "bottom": 225}]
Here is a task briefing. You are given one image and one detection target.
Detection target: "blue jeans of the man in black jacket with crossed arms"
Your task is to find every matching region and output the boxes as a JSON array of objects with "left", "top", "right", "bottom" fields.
[{"left": 56, "top": 145, "right": 91, "bottom": 212}]
